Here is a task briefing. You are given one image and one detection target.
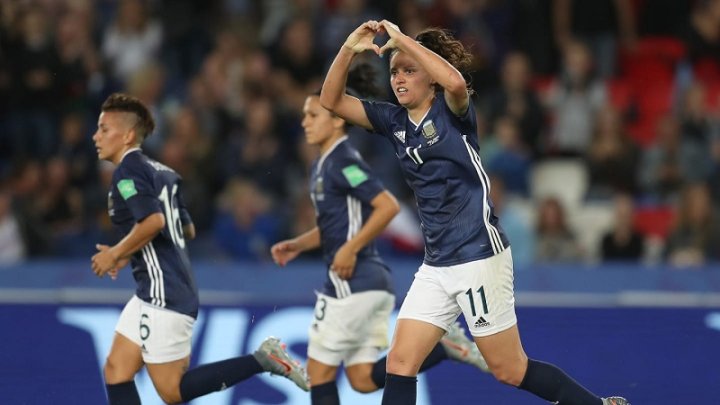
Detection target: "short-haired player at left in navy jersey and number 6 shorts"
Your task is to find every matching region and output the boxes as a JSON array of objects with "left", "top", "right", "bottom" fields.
[{"left": 92, "top": 93, "right": 308, "bottom": 405}]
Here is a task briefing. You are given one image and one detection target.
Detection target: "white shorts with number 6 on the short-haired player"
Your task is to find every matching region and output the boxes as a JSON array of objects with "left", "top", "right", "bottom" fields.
[{"left": 115, "top": 296, "right": 195, "bottom": 364}]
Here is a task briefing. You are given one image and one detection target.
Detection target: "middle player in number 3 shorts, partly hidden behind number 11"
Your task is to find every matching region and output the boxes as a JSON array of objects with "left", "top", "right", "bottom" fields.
[{"left": 271, "top": 65, "right": 487, "bottom": 405}]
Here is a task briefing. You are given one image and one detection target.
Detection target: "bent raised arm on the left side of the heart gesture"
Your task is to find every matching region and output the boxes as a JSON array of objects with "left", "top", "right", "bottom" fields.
[{"left": 320, "top": 21, "right": 380, "bottom": 130}]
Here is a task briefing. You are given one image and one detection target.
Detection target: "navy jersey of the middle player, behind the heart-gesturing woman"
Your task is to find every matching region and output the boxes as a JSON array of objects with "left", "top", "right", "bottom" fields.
[{"left": 310, "top": 136, "right": 393, "bottom": 298}]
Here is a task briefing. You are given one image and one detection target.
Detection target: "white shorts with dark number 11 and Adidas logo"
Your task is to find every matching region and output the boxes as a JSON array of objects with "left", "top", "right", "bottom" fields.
[{"left": 398, "top": 248, "right": 517, "bottom": 337}]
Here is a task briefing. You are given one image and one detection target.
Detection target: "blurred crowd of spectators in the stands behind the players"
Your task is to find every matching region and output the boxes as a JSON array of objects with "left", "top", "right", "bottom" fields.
[{"left": 0, "top": 0, "right": 720, "bottom": 268}]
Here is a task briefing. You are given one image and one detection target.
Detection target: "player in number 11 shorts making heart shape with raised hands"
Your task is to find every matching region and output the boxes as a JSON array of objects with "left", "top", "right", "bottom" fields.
[{"left": 320, "top": 20, "right": 627, "bottom": 405}]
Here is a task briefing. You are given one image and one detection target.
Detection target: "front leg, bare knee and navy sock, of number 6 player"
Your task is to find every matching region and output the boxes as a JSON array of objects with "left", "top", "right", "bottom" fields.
[{"left": 103, "top": 333, "right": 144, "bottom": 405}]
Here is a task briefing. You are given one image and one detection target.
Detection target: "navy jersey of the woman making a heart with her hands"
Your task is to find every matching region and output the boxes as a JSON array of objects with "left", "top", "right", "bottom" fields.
[{"left": 363, "top": 93, "right": 510, "bottom": 266}]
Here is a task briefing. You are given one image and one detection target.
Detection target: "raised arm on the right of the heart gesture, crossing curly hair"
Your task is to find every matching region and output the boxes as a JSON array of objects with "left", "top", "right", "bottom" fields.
[{"left": 379, "top": 20, "right": 470, "bottom": 115}]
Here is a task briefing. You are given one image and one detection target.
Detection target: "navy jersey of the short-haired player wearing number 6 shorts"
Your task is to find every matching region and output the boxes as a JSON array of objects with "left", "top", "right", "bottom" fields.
[{"left": 108, "top": 149, "right": 198, "bottom": 318}]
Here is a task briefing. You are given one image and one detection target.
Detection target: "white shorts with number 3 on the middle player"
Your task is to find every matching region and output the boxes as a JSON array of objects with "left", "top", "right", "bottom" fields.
[{"left": 308, "top": 290, "right": 395, "bottom": 367}]
